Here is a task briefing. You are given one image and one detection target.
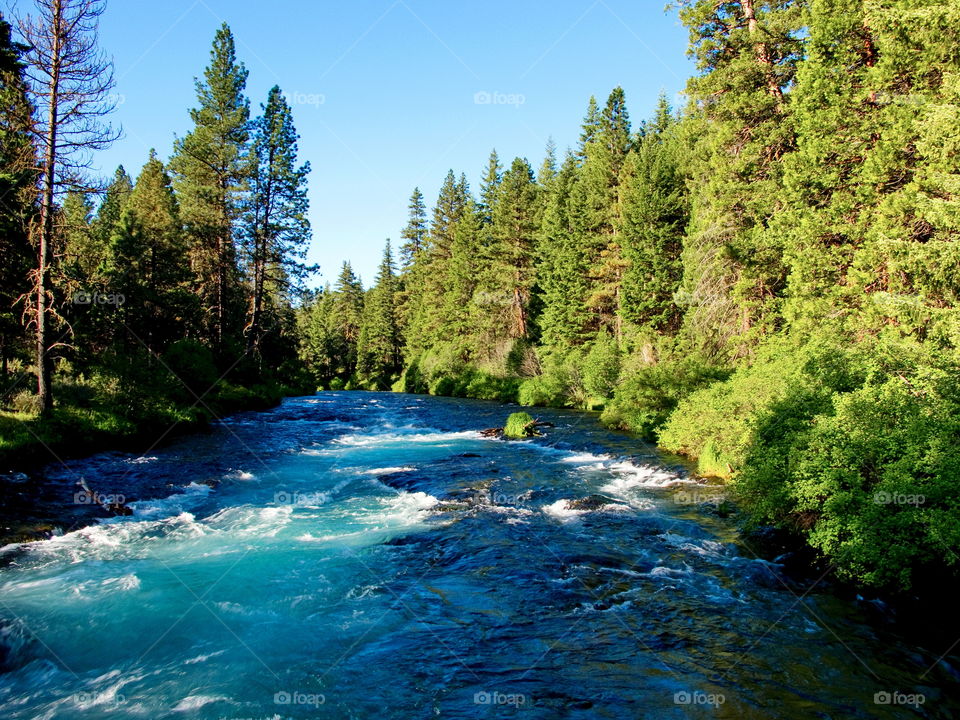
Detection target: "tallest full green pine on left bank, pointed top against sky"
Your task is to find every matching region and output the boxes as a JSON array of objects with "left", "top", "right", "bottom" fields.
[{"left": 170, "top": 23, "right": 250, "bottom": 352}]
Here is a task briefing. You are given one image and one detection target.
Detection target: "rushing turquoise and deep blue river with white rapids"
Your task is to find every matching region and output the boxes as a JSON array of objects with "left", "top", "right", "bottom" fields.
[{"left": 0, "top": 392, "right": 960, "bottom": 720}]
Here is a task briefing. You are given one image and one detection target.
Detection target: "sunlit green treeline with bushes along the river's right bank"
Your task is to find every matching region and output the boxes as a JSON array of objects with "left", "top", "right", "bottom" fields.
[{"left": 300, "top": 0, "right": 960, "bottom": 588}]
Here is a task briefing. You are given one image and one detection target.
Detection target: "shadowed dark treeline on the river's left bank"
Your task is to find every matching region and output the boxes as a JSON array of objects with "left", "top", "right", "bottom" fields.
[{"left": 0, "top": 0, "right": 313, "bottom": 457}]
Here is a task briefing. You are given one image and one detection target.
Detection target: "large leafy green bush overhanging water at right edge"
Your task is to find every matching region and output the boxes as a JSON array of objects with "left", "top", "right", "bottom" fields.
[{"left": 737, "top": 360, "right": 960, "bottom": 589}]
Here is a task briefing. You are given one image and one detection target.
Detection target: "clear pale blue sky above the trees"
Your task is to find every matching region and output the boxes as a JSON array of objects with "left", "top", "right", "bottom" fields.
[{"left": 7, "top": 0, "right": 693, "bottom": 284}]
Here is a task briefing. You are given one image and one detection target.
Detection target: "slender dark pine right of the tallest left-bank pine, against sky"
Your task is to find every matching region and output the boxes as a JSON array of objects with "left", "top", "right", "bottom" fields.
[{"left": 243, "top": 86, "right": 316, "bottom": 359}]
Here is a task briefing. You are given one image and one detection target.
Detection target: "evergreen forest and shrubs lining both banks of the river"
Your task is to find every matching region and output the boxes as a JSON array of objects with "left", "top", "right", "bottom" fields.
[{"left": 0, "top": 0, "right": 960, "bottom": 590}]
